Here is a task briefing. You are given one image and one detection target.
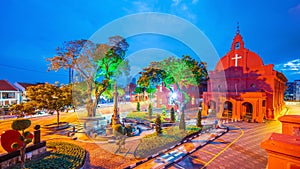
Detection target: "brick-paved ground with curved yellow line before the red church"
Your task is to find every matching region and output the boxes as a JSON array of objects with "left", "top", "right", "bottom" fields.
[{"left": 169, "top": 120, "right": 281, "bottom": 169}]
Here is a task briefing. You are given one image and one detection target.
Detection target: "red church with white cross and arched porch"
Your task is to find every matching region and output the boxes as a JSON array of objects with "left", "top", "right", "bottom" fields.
[{"left": 202, "top": 30, "right": 287, "bottom": 122}]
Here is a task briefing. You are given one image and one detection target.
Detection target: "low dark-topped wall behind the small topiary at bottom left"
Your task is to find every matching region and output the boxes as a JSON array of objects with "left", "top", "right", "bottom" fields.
[{"left": 0, "top": 141, "right": 46, "bottom": 169}]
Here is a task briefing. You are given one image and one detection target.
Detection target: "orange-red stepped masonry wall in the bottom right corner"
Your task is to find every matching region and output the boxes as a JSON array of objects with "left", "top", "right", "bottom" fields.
[{"left": 260, "top": 115, "right": 300, "bottom": 169}]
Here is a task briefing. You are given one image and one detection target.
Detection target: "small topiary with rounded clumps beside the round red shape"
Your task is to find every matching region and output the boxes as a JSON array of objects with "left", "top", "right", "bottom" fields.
[{"left": 11, "top": 119, "right": 32, "bottom": 168}]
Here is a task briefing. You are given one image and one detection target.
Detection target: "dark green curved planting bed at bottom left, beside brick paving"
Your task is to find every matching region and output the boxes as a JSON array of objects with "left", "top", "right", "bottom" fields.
[{"left": 11, "top": 142, "right": 86, "bottom": 169}]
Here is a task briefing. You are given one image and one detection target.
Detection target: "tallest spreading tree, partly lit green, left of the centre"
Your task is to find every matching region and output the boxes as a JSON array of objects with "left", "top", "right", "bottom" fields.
[{"left": 47, "top": 36, "right": 129, "bottom": 117}]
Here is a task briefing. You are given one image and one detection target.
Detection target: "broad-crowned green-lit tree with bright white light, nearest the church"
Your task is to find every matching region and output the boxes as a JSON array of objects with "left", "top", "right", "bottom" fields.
[{"left": 138, "top": 56, "right": 208, "bottom": 130}]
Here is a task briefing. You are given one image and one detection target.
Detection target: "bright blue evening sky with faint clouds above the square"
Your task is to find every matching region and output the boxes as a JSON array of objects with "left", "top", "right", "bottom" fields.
[{"left": 0, "top": 0, "right": 300, "bottom": 83}]
